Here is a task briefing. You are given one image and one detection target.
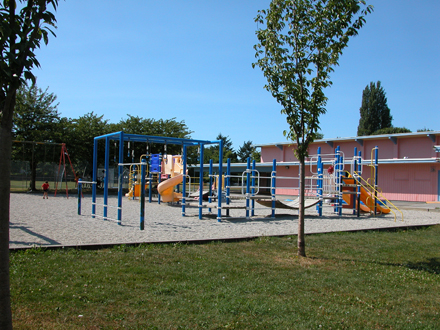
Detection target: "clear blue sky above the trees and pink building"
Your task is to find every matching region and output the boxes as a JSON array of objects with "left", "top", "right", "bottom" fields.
[{"left": 35, "top": 0, "right": 440, "bottom": 148}]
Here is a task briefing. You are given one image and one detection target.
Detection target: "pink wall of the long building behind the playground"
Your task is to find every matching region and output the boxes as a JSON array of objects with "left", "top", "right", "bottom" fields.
[{"left": 261, "top": 132, "right": 440, "bottom": 202}]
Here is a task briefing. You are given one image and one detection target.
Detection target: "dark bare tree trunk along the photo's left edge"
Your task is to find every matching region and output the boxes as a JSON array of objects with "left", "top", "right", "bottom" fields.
[{"left": 0, "top": 105, "right": 13, "bottom": 330}]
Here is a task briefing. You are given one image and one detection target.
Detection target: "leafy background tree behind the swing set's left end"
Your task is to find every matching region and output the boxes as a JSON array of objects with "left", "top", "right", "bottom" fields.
[{"left": 12, "top": 83, "right": 61, "bottom": 190}]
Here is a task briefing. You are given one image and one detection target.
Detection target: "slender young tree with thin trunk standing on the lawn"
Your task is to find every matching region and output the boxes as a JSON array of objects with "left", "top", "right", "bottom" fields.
[{"left": 253, "top": 0, "right": 372, "bottom": 256}]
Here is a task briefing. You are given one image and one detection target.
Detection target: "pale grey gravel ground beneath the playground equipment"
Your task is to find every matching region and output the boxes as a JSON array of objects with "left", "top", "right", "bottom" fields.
[{"left": 9, "top": 193, "right": 440, "bottom": 249}]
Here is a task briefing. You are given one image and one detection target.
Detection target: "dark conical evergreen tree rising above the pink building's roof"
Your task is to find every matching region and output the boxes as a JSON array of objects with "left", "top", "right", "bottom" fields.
[{"left": 357, "top": 81, "right": 393, "bottom": 136}]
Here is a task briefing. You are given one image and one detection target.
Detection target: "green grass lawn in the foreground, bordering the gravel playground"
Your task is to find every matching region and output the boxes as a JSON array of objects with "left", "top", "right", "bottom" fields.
[{"left": 10, "top": 226, "right": 440, "bottom": 329}]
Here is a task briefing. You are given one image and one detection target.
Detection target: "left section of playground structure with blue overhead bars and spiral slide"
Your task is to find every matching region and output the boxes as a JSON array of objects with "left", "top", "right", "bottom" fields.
[{"left": 87, "top": 132, "right": 223, "bottom": 230}]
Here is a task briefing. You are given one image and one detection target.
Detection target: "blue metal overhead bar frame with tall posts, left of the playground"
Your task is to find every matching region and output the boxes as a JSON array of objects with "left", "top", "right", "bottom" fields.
[{"left": 92, "top": 131, "right": 223, "bottom": 224}]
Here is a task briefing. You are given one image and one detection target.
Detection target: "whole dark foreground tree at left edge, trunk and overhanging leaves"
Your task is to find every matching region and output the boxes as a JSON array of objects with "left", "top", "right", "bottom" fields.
[{"left": 0, "top": 0, "right": 58, "bottom": 330}]
